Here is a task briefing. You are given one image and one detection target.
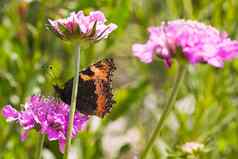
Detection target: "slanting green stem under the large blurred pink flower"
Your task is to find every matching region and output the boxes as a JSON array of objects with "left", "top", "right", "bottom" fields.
[{"left": 140, "top": 64, "right": 187, "bottom": 159}]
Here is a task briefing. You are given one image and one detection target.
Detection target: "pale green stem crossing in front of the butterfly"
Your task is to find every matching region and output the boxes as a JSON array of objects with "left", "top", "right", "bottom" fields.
[{"left": 64, "top": 45, "right": 80, "bottom": 159}]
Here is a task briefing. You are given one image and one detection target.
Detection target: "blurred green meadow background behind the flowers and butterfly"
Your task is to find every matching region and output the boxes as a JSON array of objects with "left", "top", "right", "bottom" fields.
[{"left": 0, "top": 0, "right": 238, "bottom": 159}]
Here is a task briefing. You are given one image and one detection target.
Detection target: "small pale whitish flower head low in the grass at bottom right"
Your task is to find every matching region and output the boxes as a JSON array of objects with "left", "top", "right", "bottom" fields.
[{"left": 181, "top": 142, "right": 204, "bottom": 154}]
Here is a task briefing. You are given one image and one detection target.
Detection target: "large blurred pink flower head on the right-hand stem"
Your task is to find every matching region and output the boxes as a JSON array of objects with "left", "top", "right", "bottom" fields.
[{"left": 132, "top": 20, "right": 238, "bottom": 67}]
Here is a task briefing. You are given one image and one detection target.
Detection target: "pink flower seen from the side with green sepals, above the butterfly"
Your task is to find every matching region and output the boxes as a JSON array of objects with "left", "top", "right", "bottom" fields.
[{"left": 48, "top": 11, "right": 117, "bottom": 41}]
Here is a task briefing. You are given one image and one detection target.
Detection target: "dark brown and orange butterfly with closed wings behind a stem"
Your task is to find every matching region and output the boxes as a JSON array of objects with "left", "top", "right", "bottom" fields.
[{"left": 53, "top": 58, "right": 116, "bottom": 117}]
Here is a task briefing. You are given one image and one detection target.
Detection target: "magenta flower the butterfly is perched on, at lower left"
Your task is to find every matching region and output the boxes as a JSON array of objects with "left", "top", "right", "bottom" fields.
[{"left": 2, "top": 96, "right": 88, "bottom": 152}]
